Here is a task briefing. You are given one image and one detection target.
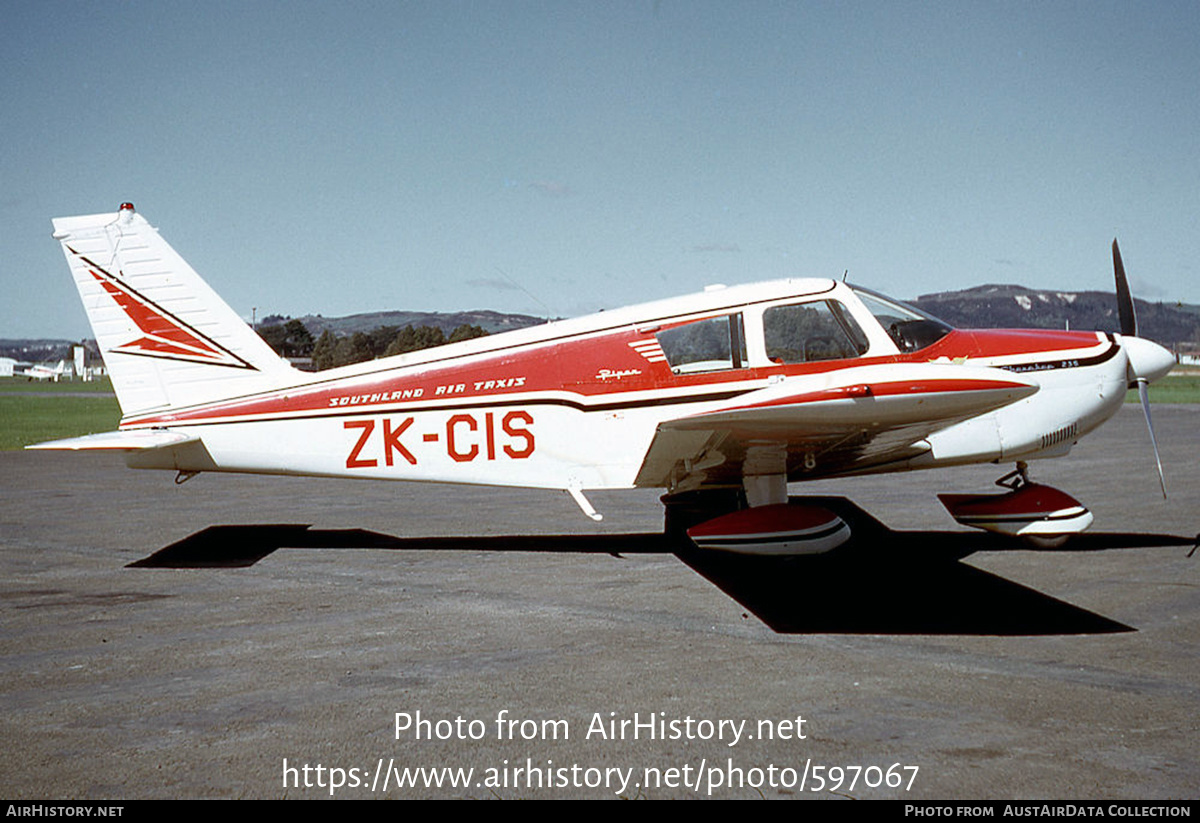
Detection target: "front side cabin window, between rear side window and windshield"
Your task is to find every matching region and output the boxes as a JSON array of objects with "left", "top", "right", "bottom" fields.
[{"left": 762, "top": 300, "right": 868, "bottom": 364}]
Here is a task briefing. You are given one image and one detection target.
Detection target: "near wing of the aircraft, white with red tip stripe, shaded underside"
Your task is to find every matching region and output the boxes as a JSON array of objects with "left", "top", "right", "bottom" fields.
[{"left": 636, "top": 362, "right": 1038, "bottom": 491}]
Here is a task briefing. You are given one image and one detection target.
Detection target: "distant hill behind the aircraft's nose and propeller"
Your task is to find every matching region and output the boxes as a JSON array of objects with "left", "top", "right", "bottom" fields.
[{"left": 908, "top": 284, "right": 1200, "bottom": 346}]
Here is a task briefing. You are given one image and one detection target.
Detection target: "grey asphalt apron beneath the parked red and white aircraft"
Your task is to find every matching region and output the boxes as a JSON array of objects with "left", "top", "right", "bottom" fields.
[{"left": 0, "top": 407, "right": 1200, "bottom": 799}]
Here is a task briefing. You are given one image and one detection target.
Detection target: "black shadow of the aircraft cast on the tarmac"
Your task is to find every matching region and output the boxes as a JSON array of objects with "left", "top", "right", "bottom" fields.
[{"left": 128, "top": 497, "right": 1196, "bottom": 635}]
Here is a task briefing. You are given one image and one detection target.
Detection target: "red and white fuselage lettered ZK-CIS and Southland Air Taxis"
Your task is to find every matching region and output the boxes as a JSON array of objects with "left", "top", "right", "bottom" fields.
[{"left": 121, "top": 280, "right": 1129, "bottom": 488}]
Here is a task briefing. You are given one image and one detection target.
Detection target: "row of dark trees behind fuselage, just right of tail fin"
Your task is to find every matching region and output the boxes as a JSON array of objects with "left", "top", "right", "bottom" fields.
[{"left": 257, "top": 320, "right": 487, "bottom": 371}]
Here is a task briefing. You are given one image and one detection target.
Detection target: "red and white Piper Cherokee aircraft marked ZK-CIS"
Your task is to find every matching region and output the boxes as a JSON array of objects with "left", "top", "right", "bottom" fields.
[{"left": 31, "top": 203, "right": 1174, "bottom": 554}]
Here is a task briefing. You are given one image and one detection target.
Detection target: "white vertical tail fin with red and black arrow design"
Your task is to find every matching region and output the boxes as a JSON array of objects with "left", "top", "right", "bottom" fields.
[{"left": 54, "top": 203, "right": 295, "bottom": 419}]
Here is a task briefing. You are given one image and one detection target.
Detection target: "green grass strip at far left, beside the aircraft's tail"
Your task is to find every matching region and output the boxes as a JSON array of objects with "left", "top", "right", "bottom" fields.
[{"left": 0, "top": 392, "right": 121, "bottom": 451}]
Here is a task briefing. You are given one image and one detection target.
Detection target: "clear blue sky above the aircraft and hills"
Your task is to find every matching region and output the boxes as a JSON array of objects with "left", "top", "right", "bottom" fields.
[{"left": 0, "top": 0, "right": 1200, "bottom": 337}]
